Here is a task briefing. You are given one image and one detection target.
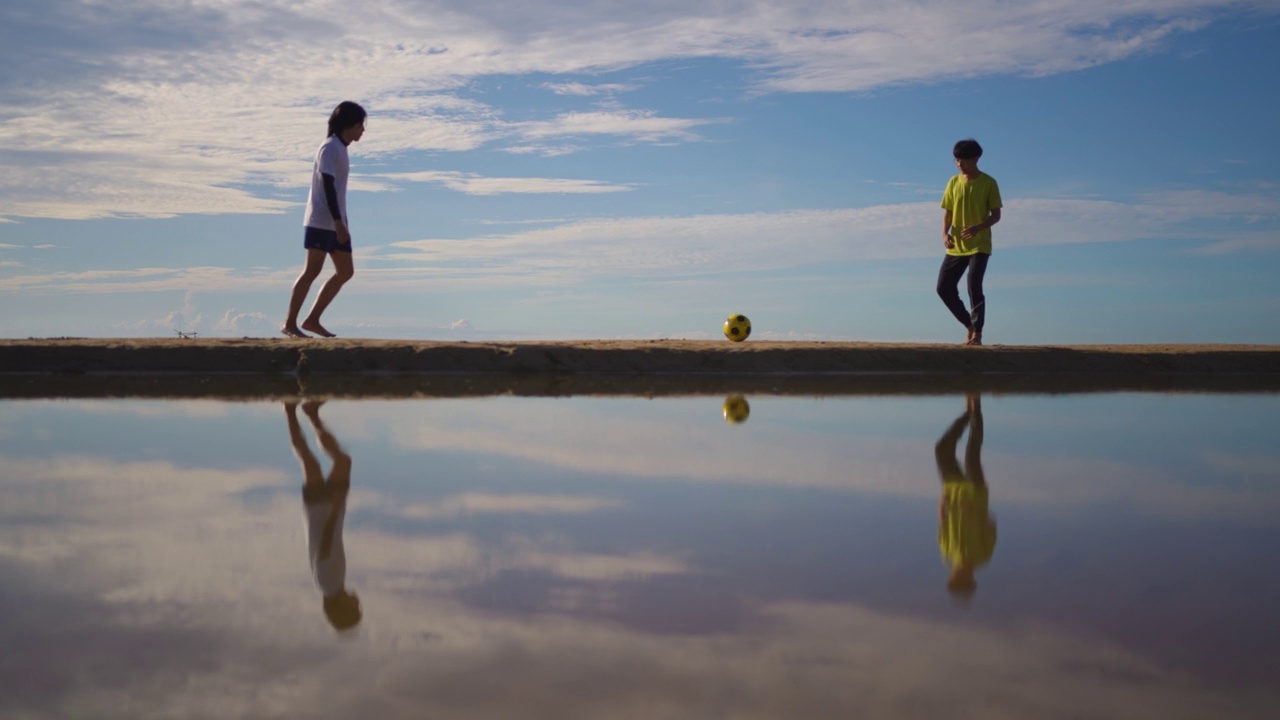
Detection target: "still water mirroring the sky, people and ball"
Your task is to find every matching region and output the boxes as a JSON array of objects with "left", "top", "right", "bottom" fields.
[{"left": 0, "top": 392, "right": 1280, "bottom": 720}]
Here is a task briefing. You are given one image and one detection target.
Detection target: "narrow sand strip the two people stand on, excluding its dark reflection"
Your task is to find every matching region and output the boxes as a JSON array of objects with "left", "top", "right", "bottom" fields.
[{"left": 0, "top": 338, "right": 1280, "bottom": 375}]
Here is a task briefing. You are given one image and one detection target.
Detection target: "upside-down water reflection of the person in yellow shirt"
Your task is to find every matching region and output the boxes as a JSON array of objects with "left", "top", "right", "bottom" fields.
[{"left": 933, "top": 395, "right": 996, "bottom": 600}]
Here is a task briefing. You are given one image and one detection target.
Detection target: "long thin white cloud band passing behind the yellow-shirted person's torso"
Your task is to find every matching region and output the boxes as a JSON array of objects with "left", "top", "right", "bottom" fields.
[{"left": 380, "top": 195, "right": 1280, "bottom": 282}]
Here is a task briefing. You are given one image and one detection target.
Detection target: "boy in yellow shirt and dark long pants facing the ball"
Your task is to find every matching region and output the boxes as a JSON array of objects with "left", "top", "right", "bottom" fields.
[{"left": 937, "top": 138, "right": 1002, "bottom": 345}]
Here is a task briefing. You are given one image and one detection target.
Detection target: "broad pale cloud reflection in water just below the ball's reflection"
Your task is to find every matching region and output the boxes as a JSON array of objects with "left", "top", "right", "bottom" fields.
[{"left": 393, "top": 398, "right": 937, "bottom": 497}]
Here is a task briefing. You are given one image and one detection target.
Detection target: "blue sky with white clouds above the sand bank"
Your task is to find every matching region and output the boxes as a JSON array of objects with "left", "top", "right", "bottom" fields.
[{"left": 0, "top": 0, "right": 1280, "bottom": 345}]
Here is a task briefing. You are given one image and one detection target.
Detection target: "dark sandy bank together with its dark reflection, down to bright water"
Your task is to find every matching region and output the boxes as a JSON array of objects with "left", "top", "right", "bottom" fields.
[{"left": 0, "top": 338, "right": 1280, "bottom": 397}]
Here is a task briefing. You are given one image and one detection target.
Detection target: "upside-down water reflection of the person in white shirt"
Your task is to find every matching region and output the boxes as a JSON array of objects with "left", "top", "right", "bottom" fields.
[{"left": 284, "top": 401, "right": 361, "bottom": 630}]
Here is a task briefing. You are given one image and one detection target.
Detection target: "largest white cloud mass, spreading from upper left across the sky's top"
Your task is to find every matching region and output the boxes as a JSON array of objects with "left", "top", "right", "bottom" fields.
[{"left": 0, "top": 0, "right": 1276, "bottom": 218}]
